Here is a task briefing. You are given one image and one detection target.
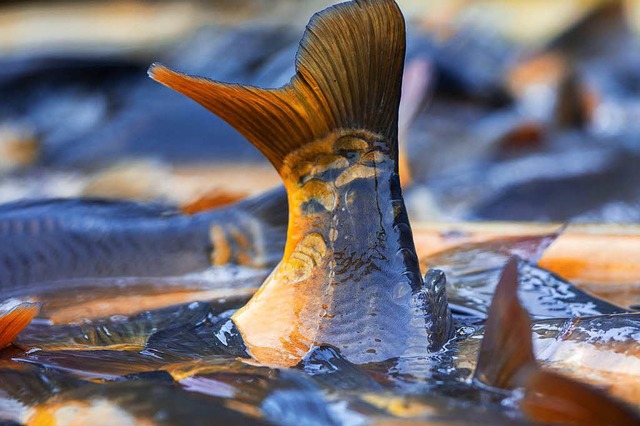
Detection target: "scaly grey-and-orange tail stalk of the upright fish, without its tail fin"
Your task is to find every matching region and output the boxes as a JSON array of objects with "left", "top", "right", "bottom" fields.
[{"left": 234, "top": 133, "right": 428, "bottom": 363}]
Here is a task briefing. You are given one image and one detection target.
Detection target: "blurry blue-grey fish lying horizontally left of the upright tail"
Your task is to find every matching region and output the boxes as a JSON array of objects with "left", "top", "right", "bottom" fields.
[{"left": 0, "top": 185, "right": 287, "bottom": 294}]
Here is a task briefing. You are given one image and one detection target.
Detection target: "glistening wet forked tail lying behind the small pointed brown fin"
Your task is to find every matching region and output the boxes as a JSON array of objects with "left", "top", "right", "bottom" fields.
[{"left": 421, "top": 231, "right": 629, "bottom": 319}]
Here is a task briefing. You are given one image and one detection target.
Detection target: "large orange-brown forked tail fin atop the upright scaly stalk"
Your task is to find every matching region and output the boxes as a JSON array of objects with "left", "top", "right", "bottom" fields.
[{"left": 149, "top": 0, "right": 405, "bottom": 170}]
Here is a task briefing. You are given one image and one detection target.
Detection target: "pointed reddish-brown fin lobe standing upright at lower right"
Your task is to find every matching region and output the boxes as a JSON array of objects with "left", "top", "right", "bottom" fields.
[{"left": 475, "top": 257, "right": 537, "bottom": 389}]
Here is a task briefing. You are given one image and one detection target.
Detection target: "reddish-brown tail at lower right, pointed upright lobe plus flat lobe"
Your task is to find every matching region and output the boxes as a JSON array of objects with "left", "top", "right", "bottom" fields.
[{"left": 475, "top": 258, "right": 640, "bottom": 425}]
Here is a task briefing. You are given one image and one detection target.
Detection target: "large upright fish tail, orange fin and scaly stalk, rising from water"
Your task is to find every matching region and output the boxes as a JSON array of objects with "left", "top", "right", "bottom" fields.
[{"left": 149, "top": 0, "right": 450, "bottom": 366}]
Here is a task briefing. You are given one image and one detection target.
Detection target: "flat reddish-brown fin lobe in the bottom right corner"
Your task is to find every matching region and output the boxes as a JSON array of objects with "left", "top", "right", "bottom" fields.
[{"left": 520, "top": 370, "right": 640, "bottom": 426}]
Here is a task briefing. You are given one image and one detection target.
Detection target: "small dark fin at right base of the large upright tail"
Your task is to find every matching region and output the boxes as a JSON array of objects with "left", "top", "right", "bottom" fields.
[{"left": 424, "top": 269, "right": 455, "bottom": 352}]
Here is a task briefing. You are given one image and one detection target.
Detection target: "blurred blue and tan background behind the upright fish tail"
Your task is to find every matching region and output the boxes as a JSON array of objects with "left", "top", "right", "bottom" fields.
[{"left": 0, "top": 0, "right": 640, "bottom": 223}]
